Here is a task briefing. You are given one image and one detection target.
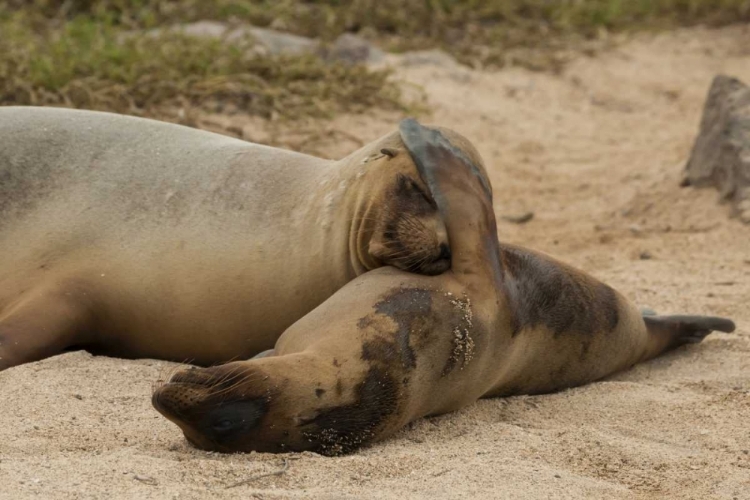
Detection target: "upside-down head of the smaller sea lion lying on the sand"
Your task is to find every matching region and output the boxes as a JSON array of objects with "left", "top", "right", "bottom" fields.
[{"left": 152, "top": 353, "right": 368, "bottom": 455}]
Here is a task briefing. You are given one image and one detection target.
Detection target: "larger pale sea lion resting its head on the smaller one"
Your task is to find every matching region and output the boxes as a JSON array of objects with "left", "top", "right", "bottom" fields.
[{"left": 0, "top": 107, "right": 458, "bottom": 370}]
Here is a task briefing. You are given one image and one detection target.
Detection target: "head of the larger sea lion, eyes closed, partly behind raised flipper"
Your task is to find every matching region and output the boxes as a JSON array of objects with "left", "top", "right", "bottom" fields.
[{"left": 352, "top": 124, "right": 489, "bottom": 275}]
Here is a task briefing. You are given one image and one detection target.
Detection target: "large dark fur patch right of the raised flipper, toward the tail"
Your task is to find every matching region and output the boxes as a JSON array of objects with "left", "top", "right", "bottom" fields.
[{"left": 501, "top": 247, "right": 620, "bottom": 338}]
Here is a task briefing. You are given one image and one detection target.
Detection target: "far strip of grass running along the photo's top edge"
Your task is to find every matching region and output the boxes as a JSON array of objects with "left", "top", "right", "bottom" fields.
[{"left": 10, "top": 0, "right": 750, "bottom": 65}]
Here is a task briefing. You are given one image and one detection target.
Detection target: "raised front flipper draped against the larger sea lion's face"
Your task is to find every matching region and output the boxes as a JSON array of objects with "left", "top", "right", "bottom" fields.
[{"left": 399, "top": 118, "right": 500, "bottom": 280}]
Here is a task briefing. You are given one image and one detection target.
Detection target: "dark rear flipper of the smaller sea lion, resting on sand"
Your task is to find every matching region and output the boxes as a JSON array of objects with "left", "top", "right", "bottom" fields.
[{"left": 643, "top": 311, "right": 735, "bottom": 357}]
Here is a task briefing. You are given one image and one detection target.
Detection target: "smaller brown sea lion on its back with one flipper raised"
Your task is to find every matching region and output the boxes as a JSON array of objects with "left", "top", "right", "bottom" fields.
[{"left": 152, "top": 121, "right": 734, "bottom": 454}]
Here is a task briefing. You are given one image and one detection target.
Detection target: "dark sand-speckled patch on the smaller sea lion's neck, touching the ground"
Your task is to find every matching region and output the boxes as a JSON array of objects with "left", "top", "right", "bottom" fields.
[{"left": 302, "top": 366, "right": 398, "bottom": 455}]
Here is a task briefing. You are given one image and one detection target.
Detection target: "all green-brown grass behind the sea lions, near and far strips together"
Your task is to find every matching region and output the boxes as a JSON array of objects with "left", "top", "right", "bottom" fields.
[{"left": 0, "top": 0, "right": 750, "bottom": 121}]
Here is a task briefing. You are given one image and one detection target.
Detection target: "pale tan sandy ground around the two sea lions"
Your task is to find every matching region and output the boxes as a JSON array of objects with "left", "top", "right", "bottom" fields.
[{"left": 0, "top": 27, "right": 750, "bottom": 499}]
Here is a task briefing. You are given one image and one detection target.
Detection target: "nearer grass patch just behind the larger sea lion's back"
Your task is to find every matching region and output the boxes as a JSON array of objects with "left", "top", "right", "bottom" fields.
[{"left": 0, "top": 9, "right": 412, "bottom": 118}]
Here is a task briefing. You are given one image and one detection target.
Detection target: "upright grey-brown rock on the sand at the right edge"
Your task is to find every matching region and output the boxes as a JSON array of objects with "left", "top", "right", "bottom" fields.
[{"left": 683, "top": 75, "right": 750, "bottom": 222}]
